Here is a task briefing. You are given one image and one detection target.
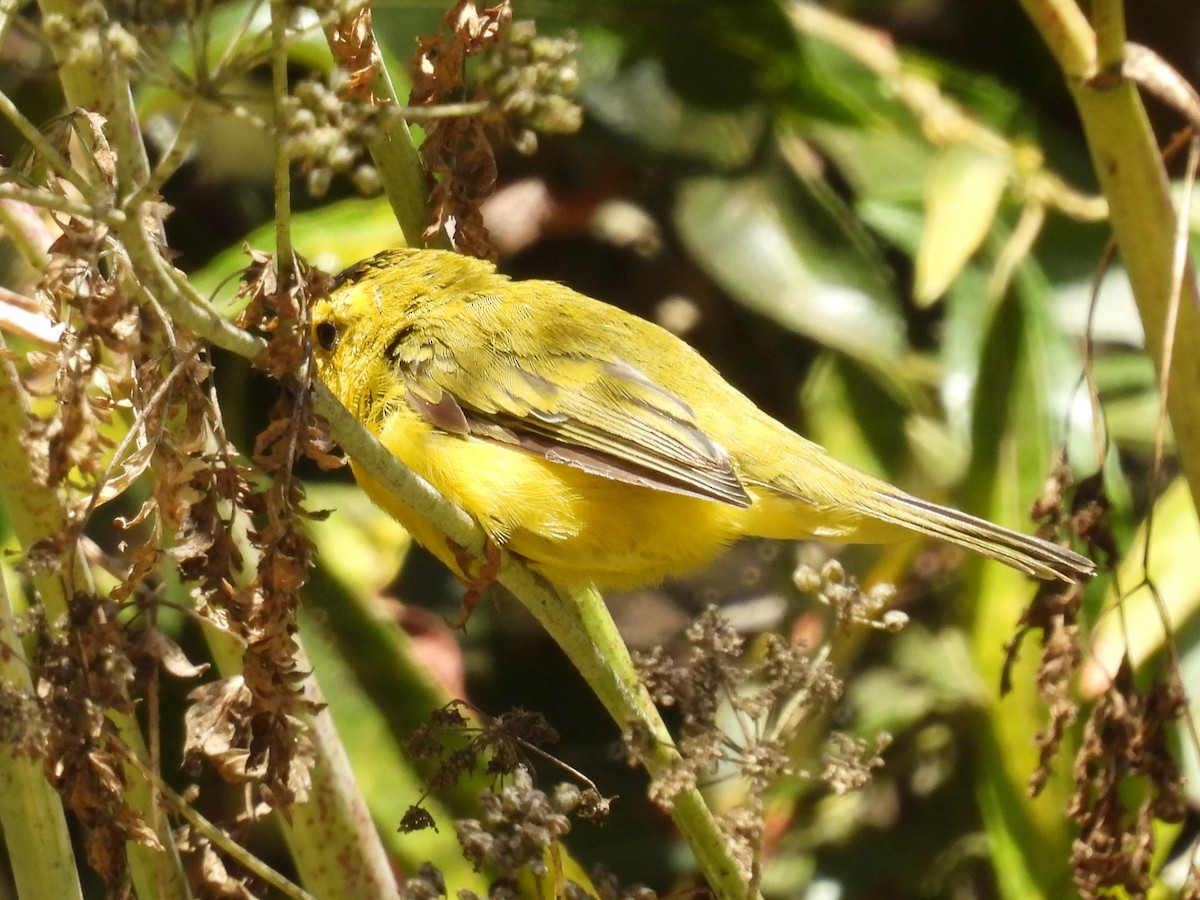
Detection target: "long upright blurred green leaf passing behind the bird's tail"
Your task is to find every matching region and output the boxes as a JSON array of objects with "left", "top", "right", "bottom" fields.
[{"left": 966, "top": 260, "right": 1080, "bottom": 898}]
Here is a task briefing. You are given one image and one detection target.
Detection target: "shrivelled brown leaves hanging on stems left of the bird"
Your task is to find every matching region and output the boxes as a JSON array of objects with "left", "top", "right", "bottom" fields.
[{"left": 6, "top": 114, "right": 328, "bottom": 893}]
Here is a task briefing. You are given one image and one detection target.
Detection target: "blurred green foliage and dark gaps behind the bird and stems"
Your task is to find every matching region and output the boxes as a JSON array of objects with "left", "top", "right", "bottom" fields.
[{"left": 0, "top": 0, "right": 1200, "bottom": 899}]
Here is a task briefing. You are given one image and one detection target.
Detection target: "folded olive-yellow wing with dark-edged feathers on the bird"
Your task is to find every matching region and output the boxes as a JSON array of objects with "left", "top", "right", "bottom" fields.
[{"left": 386, "top": 312, "right": 750, "bottom": 508}]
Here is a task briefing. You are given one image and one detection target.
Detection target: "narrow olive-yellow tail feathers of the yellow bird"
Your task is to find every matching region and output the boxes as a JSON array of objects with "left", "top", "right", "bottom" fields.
[{"left": 871, "top": 492, "right": 1096, "bottom": 583}]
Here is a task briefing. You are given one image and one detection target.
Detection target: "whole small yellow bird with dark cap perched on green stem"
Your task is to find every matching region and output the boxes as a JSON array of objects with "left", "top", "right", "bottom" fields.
[{"left": 312, "top": 250, "right": 1094, "bottom": 595}]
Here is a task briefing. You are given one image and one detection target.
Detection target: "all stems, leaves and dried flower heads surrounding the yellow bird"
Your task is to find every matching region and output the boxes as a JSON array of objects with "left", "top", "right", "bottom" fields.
[{"left": 0, "top": 0, "right": 1200, "bottom": 900}]
